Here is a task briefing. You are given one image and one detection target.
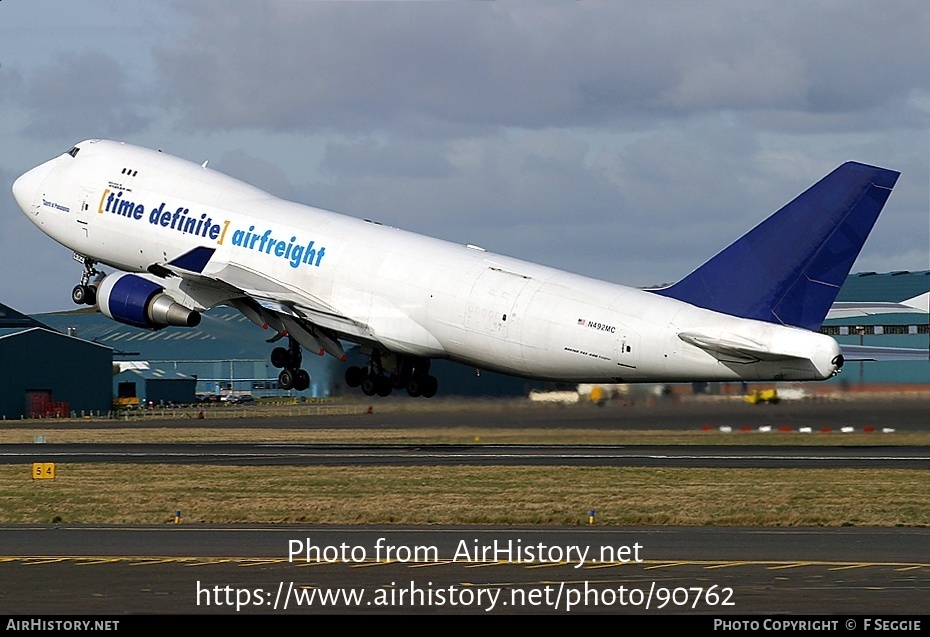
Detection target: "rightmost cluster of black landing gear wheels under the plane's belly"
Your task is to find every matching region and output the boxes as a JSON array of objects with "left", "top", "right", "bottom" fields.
[{"left": 345, "top": 350, "right": 439, "bottom": 398}]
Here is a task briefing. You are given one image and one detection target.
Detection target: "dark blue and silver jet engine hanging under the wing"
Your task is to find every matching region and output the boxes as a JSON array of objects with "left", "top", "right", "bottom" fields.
[{"left": 97, "top": 273, "right": 200, "bottom": 330}]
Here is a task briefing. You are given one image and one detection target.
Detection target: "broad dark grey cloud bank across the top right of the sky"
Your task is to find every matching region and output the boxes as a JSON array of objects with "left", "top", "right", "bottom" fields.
[{"left": 155, "top": 1, "right": 930, "bottom": 132}]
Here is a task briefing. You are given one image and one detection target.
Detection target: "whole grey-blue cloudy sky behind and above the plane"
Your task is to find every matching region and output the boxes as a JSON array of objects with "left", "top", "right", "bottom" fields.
[{"left": 0, "top": 0, "right": 930, "bottom": 312}]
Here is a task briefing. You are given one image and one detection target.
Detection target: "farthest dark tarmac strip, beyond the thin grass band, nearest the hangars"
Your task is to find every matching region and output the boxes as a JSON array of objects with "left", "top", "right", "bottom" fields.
[{"left": 10, "top": 394, "right": 930, "bottom": 434}]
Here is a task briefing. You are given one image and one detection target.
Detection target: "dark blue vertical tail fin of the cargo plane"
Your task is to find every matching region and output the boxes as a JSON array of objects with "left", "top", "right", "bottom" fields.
[{"left": 654, "top": 162, "right": 900, "bottom": 330}]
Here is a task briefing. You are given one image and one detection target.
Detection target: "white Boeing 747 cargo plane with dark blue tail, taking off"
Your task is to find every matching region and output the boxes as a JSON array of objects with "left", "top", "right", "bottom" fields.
[{"left": 13, "top": 139, "right": 898, "bottom": 397}]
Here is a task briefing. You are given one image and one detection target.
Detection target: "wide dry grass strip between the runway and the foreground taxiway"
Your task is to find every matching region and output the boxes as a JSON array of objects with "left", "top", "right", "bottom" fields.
[{"left": 0, "top": 464, "right": 930, "bottom": 526}]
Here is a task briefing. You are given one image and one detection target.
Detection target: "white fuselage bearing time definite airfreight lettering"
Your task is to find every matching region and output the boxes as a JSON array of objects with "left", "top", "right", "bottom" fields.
[{"left": 14, "top": 140, "right": 840, "bottom": 382}]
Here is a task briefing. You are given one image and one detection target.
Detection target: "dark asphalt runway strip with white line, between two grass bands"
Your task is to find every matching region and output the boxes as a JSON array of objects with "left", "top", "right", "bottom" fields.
[{"left": 0, "top": 443, "right": 930, "bottom": 469}]
